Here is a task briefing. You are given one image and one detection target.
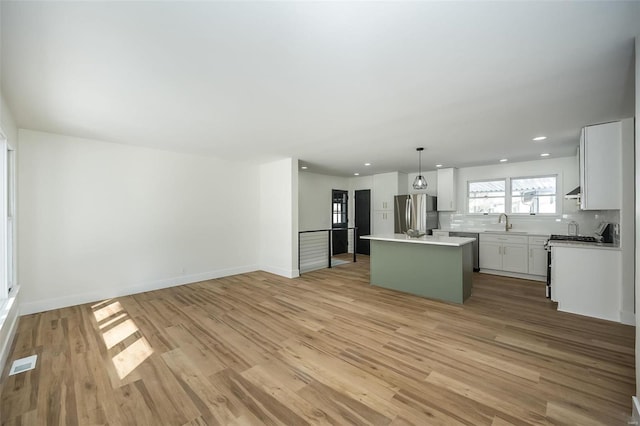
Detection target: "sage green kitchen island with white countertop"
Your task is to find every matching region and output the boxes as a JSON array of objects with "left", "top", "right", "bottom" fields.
[{"left": 361, "top": 234, "right": 475, "bottom": 303}]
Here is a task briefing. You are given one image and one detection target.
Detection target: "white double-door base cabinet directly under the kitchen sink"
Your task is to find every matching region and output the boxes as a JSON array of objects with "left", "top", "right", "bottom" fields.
[{"left": 480, "top": 234, "right": 528, "bottom": 274}]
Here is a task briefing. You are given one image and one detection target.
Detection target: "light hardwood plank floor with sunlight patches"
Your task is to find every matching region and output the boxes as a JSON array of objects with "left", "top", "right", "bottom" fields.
[{"left": 0, "top": 256, "right": 634, "bottom": 426}]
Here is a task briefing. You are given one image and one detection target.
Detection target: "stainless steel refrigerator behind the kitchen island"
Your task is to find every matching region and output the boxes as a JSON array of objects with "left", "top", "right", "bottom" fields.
[{"left": 393, "top": 194, "right": 438, "bottom": 235}]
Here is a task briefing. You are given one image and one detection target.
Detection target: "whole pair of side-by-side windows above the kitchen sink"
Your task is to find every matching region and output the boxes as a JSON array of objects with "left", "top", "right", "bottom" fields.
[{"left": 467, "top": 175, "right": 558, "bottom": 214}]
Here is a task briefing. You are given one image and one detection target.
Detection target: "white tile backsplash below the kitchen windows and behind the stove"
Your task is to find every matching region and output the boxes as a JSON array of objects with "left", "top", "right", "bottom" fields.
[{"left": 439, "top": 210, "right": 624, "bottom": 235}]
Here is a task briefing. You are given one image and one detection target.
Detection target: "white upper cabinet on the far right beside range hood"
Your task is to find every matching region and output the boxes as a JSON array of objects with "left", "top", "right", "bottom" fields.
[{"left": 579, "top": 121, "right": 622, "bottom": 210}]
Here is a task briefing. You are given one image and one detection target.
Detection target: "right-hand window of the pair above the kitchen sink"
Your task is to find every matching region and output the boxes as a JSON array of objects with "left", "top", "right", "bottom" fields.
[{"left": 511, "top": 176, "right": 557, "bottom": 214}]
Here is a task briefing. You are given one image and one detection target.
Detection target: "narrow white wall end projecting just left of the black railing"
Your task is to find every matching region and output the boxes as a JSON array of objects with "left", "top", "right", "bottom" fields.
[{"left": 258, "top": 158, "right": 300, "bottom": 278}]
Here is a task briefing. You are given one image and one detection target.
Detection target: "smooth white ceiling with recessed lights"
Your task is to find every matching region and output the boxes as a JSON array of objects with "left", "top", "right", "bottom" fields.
[{"left": 0, "top": 1, "right": 640, "bottom": 175}]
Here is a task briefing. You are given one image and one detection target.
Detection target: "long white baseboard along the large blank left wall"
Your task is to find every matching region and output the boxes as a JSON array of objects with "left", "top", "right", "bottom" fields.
[{"left": 20, "top": 265, "right": 258, "bottom": 315}]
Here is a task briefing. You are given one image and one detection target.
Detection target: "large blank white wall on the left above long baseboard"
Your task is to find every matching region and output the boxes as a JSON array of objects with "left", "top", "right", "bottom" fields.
[{"left": 18, "top": 130, "right": 258, "bottom": 314}]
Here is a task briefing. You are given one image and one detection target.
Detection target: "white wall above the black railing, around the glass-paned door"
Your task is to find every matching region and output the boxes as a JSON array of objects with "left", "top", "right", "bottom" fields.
[{"left": 298, "top": 171, "right": 353, "bottom": 231}]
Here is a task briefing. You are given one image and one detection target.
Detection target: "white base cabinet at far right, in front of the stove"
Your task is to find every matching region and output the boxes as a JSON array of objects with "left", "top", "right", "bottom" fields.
[{"left": 551, "top": 246, "right": 622, "bottom": 322}]
